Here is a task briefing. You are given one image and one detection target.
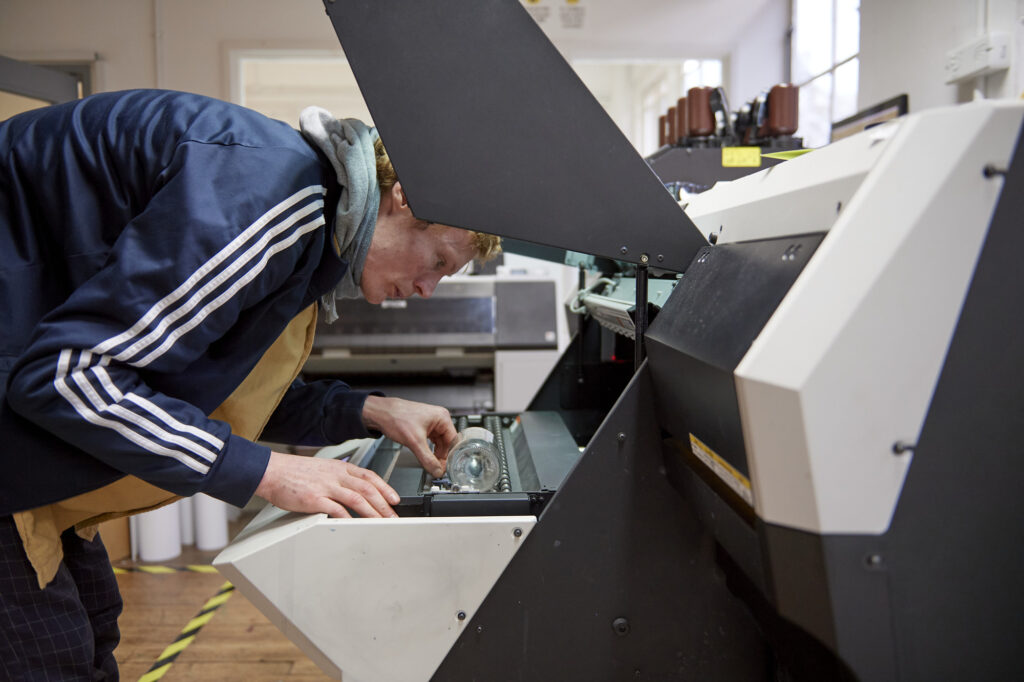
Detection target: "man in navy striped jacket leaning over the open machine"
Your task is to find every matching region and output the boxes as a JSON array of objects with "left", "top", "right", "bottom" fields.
[{"left": 0, "top": 90, "right": 500, "bottom": 680}]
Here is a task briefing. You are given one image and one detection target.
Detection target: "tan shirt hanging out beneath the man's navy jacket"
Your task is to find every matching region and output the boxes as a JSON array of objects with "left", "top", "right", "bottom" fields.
[{"left": 14, "top": 304, "right": 316, "bottom": 589}]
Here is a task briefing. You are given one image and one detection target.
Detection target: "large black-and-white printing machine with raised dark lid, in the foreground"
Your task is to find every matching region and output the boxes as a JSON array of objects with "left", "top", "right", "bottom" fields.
[{"left": 216, "top": 0, "right": 1024, "bottom": 682}]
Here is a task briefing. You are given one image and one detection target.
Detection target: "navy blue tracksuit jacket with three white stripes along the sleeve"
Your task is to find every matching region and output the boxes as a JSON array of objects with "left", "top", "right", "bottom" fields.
[{"left": 0, "top": 90, "right": 369, "bottom": 514}]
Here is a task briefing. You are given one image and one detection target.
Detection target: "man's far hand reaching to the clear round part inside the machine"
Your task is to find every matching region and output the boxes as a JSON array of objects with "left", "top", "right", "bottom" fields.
[{"left": 362, "top": 395, "right": 459, "bottom": 478}]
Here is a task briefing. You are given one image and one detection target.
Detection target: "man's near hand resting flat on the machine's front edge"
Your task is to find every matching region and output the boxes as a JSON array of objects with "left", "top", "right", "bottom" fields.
[{"left": 256, "top": 453, "right": 400, "bottom": 518}]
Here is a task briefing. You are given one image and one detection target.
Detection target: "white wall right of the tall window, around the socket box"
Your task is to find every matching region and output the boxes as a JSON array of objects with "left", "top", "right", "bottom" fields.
[{"left": 857, "top": 0, "right": 1024, "bottom": 111}]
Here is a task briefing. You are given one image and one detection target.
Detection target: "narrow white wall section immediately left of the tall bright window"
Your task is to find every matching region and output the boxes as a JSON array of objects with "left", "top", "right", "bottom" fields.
[{"left": 726, "top": 0, "right": 790, "bottom": 108}]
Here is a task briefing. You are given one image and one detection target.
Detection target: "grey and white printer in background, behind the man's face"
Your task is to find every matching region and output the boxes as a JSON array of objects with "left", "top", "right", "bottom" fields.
[{"left": 303, "top": 274, "right": 567, "bottom": 413}]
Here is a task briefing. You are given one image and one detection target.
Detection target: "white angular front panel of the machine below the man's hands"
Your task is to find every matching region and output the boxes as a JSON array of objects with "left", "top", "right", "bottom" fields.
[{"left": 214, "top": 508, "right": 537, "bottom": 682}]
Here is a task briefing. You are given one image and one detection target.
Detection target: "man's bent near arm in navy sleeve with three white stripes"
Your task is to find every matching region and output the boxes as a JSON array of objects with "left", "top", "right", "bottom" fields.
[{"left": 7, "top": 143, "right": 324, "bottom": 505}]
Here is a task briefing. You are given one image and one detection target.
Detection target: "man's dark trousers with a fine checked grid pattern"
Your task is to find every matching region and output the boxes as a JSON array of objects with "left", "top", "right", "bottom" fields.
[{"left": 0, "top": 516, "right": 122, "bottom": 682}]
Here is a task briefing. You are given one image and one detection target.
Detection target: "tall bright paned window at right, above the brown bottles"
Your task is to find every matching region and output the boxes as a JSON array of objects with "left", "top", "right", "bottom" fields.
[{"left": 791, "top": 0, "right": 860, "bottom": 146}]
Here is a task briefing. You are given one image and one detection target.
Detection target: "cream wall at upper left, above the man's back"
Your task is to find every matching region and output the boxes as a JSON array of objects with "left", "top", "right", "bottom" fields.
[{"left": 0, "top": 0, "right": 340, "bottom": 99}]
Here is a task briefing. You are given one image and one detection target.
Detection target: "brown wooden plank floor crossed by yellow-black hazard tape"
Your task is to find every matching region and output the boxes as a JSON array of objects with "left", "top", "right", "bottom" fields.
[{"left": 115, "top": 550, "right": 331, "bottom": 682}]
